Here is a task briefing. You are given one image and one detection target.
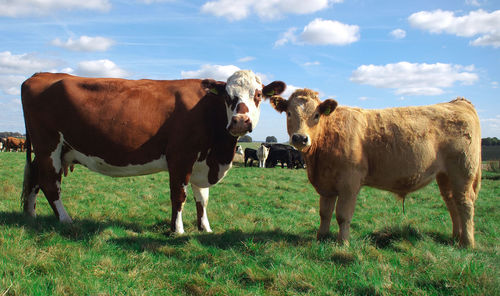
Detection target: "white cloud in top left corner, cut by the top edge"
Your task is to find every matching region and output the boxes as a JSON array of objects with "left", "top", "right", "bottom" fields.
[{"left": 0, "top": 0, "right": 111, "bottom": 17}]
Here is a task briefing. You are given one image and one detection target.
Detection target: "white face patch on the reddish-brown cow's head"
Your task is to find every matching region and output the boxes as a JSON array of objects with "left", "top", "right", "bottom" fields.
[{"left": 226, "top": 70, "right": 262, "bottom": 130}]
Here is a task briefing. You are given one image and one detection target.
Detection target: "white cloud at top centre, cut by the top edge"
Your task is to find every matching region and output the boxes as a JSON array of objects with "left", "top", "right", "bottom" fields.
[{"left": 201, "top": 0, "right": 343, "bottom": 21}]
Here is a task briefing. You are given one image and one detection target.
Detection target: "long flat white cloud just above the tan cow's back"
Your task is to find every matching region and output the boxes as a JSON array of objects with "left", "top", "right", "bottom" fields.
[{"left": 350, "top": 62, "right": 478, "bottom": 95}]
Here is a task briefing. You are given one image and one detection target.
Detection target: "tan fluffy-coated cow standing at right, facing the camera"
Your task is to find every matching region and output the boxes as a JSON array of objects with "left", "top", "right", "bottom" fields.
[{"left": 271, "top": 89, "right": 481, "bottom": 247}]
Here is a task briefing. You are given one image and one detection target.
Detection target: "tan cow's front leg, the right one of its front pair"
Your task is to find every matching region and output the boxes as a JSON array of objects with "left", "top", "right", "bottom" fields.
[{"left": 335, "top": 184, "right": 359, "bottom": 243}]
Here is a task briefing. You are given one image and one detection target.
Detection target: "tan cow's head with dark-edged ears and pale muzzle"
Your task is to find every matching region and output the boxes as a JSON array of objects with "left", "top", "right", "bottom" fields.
[{"left": 271, "top": 89, "right": 337, "bottom": 151}]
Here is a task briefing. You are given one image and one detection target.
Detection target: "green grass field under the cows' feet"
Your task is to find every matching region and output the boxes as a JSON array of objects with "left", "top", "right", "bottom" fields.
[{"left": 0, "top": 153, "right": 500, "bottom": 295}]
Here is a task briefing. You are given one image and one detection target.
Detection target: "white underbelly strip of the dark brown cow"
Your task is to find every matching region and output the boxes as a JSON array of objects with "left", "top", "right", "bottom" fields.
[{"left": 64, "top": 150, "right": 168, "bottom": 177}]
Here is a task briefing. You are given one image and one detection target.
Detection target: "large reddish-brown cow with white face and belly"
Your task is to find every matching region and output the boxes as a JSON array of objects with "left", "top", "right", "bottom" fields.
[{"left": 21, "top": 70, "right": 286, "bottom": 233}]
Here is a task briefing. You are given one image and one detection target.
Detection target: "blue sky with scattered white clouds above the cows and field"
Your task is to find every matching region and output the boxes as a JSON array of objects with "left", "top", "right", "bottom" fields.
[{"left": 0, "top": 0, "right": 500, "bottom": 141}]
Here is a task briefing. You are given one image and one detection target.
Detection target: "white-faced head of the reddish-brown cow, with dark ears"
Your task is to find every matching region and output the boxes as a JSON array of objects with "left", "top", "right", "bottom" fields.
[{"left": 203, "top": 70, "right": 286, "bottom": 137}]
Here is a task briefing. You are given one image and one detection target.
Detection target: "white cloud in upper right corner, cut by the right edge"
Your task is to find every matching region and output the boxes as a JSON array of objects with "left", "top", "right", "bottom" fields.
[{"left": 408, "top": 9, "right": 500, "bottom": 47}]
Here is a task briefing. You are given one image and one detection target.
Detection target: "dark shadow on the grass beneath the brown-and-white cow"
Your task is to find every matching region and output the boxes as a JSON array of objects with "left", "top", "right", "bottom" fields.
[{"left": 0, "top": 212, "right": 311, "bottom": 252}]
